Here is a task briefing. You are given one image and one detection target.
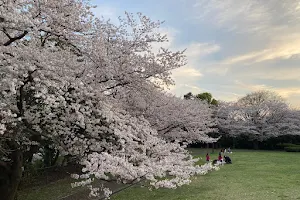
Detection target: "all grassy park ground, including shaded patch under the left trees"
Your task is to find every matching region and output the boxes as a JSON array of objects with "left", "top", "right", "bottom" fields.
[{"left": 19, "top": 149, "right": 300, "bottom": 200}]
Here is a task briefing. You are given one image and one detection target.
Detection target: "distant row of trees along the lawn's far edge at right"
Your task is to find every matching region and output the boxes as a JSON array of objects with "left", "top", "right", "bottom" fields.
[{"left": 184, "top": 91, "right": 300, "bottom": 149}]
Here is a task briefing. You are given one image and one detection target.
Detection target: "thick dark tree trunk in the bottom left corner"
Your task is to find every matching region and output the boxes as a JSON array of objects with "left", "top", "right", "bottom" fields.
[{"left": 0, "top": 150, "right": 23, "bottom": 200}]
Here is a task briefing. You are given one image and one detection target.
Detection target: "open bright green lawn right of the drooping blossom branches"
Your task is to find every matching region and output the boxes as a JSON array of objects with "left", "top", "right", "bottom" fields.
[{"left": 112, "top": 149, "right": 300, "bottom": 200}]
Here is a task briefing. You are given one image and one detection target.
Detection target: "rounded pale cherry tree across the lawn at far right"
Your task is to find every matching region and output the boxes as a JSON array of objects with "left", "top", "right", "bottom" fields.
[{"left": 218, "top": 91, "right": 291, "bottom": 148}]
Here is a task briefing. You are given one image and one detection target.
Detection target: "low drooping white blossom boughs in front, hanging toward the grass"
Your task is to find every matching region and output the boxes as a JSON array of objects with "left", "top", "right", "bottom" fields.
[{"left": 35, "top": 92, "right": 218, "bottom": 198}]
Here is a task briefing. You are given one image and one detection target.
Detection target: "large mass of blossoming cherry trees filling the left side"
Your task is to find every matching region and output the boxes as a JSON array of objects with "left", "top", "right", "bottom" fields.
[{"left": 0, "top": 0, "right": 216, "bottom": 200}]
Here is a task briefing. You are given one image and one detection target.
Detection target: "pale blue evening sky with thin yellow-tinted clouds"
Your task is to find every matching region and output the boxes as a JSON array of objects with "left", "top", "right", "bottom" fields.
[{"left": 91, "top": 0, "right": 300, "bottom": 108}]
